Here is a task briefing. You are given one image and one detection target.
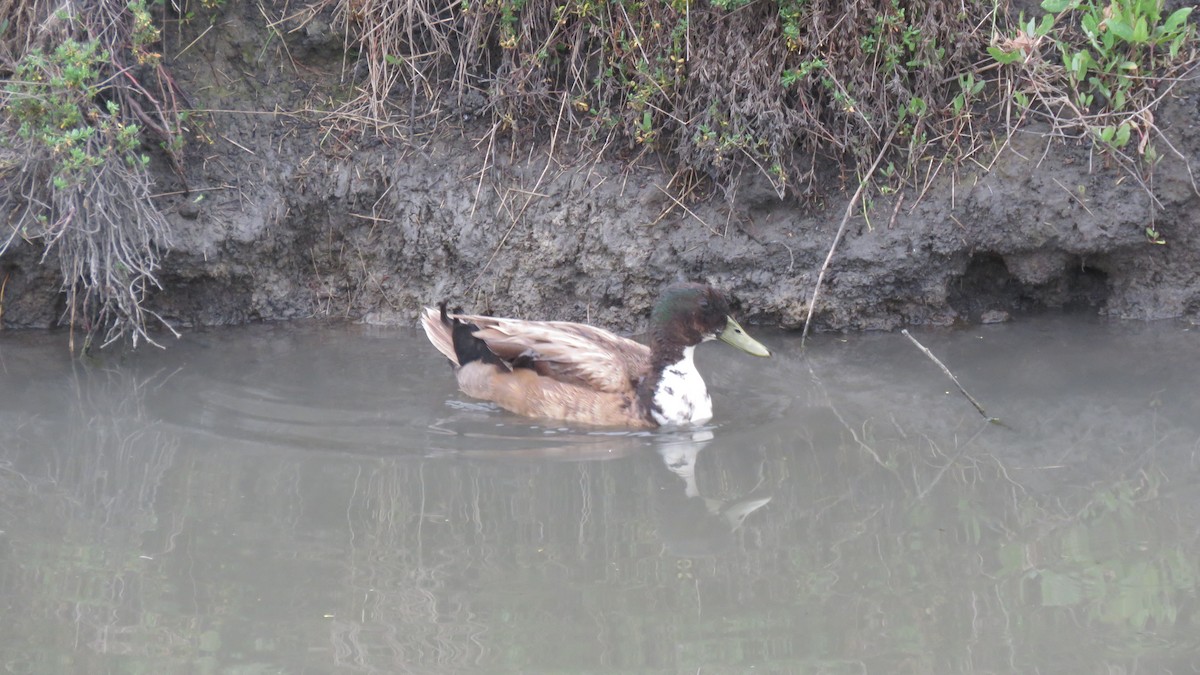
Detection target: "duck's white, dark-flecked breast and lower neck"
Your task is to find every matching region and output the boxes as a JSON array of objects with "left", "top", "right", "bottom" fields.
[{"left": 641, "top": 345, "right": 713, "bottom": 425}]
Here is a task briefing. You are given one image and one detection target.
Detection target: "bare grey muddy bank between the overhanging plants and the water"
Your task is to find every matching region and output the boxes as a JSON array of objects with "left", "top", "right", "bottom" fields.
[{"left": 0, "top": 4, "right": 1200, "bottom": 330}]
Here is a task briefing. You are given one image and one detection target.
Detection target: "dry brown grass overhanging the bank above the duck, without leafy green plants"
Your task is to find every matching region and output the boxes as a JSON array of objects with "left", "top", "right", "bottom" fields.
[{"left": 308, "top": 0, "right": 992, "bottom": 195}]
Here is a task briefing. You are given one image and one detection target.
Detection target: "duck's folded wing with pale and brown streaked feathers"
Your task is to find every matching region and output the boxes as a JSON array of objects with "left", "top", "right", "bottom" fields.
[{"left": 452, "top": 315, "right": 650, "bottom": 393}]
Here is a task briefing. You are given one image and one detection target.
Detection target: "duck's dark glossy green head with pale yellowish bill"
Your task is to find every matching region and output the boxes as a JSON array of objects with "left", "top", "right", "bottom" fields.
[{"left": 650, "top": 283, "right": 770, "bottom": 357}]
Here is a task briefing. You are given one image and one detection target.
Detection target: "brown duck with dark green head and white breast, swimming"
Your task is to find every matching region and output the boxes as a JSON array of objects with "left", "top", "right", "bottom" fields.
[{"left": 421, "top": 283, "right": 770, "bottom": 429}]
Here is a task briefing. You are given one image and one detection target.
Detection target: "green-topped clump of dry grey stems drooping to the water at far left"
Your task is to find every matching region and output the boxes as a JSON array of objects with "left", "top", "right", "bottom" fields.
[{"left": 0, "top": 0, "right": 182, "bottom": 351}]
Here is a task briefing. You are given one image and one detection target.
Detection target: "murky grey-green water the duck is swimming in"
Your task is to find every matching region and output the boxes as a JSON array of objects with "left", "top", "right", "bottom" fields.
[{"left": 0, "top": 318, "right": 1200, "bottom": 674}]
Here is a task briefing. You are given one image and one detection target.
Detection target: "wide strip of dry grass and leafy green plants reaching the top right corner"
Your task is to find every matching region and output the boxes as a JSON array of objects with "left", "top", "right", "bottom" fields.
[{"left": 310, "top": 0, "right": 1196, "bottom": 212}]
